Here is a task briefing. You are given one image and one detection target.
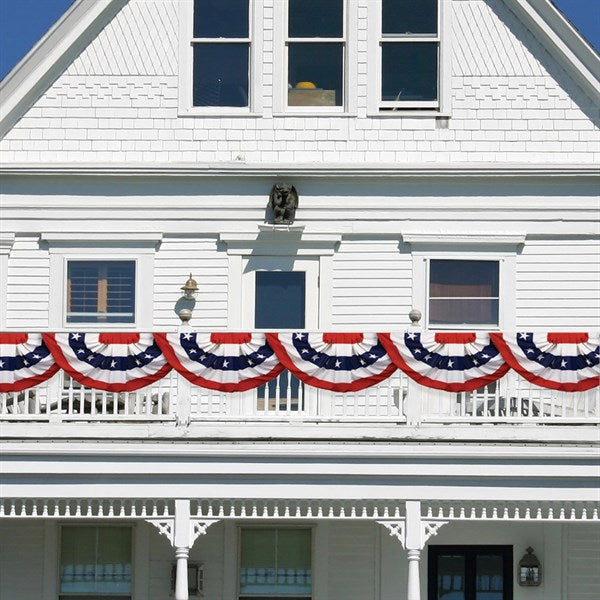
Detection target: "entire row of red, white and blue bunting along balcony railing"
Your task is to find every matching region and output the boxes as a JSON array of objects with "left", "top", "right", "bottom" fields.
[{"left": 0, "top": 331, "right": 600, "bottom": 393}]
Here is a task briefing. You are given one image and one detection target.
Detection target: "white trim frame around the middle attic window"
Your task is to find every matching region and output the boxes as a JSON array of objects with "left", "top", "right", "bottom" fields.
[{"left": 273, "top": 0, "right": 358, "bottom": 117}]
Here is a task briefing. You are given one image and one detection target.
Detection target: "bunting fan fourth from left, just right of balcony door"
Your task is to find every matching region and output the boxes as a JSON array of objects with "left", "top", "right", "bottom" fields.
[{"left": 267, "top": 332, "right": 396, "bottom": 392}]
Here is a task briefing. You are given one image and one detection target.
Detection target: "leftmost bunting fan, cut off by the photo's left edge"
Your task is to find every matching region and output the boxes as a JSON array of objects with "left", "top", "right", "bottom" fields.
[{"left": 0, "top": 333, "right": 59, "bottom": 392}]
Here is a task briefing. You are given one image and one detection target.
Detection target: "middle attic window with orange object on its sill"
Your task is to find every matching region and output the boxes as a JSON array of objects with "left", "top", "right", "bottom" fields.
[{"left": 287, "top": 0, "right": 345, "bottom": 106}]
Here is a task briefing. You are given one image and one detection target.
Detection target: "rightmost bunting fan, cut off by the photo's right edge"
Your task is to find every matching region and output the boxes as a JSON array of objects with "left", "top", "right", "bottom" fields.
[{"left": 491, "top": 332, "right": 600, "bottom": 392}]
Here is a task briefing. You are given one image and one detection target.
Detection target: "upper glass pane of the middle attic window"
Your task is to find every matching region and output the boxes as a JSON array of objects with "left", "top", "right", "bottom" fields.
[{"left": 288, "top": 0, "right": 344, "bottom": 37}]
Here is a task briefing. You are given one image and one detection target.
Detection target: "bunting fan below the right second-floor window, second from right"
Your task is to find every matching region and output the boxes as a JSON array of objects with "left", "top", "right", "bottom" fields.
[{"left": 379, "top": 331, "right": 509, "bottom": 392}]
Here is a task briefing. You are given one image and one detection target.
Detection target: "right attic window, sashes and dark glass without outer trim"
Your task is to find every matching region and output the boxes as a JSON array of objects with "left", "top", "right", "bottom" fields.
[{"left": 380, "top": 0, "right": 440, "bottom": 110}]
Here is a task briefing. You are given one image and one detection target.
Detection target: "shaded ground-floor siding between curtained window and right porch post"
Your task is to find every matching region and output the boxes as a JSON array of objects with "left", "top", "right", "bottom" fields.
[{"left": 327, "top": 522, "right": 375, "bottom": 600}]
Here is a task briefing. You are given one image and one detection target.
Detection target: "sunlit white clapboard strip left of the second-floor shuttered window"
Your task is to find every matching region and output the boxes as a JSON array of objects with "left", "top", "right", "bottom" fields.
[{"left": 5, "top": 236, "right": 50, "bottom": 330}]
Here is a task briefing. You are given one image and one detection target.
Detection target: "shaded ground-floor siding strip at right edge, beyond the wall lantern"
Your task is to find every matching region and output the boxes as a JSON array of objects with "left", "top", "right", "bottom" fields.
[{"left": 566, "top": 525, "right": 600, "bottom": 600}]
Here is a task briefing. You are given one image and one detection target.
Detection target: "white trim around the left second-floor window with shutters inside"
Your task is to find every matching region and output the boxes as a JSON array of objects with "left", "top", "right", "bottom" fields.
[{"left": 41, "top": 234, "right": 161, "bottom": 331}]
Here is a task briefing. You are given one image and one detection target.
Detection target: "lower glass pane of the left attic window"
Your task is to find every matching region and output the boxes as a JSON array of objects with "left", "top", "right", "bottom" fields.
[{"left": 193, "top": 44, "right": 249, "bottom": 106}]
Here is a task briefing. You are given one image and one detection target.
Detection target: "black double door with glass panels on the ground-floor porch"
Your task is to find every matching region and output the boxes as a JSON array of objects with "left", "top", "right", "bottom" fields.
[{"left": 428, "top": 546, "right": 513, "bottom": 600}]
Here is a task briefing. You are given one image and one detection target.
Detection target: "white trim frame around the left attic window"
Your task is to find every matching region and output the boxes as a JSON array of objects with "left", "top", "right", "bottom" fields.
[{"left": 178, "top": 0, "right": 264, "bottom": 117}]
